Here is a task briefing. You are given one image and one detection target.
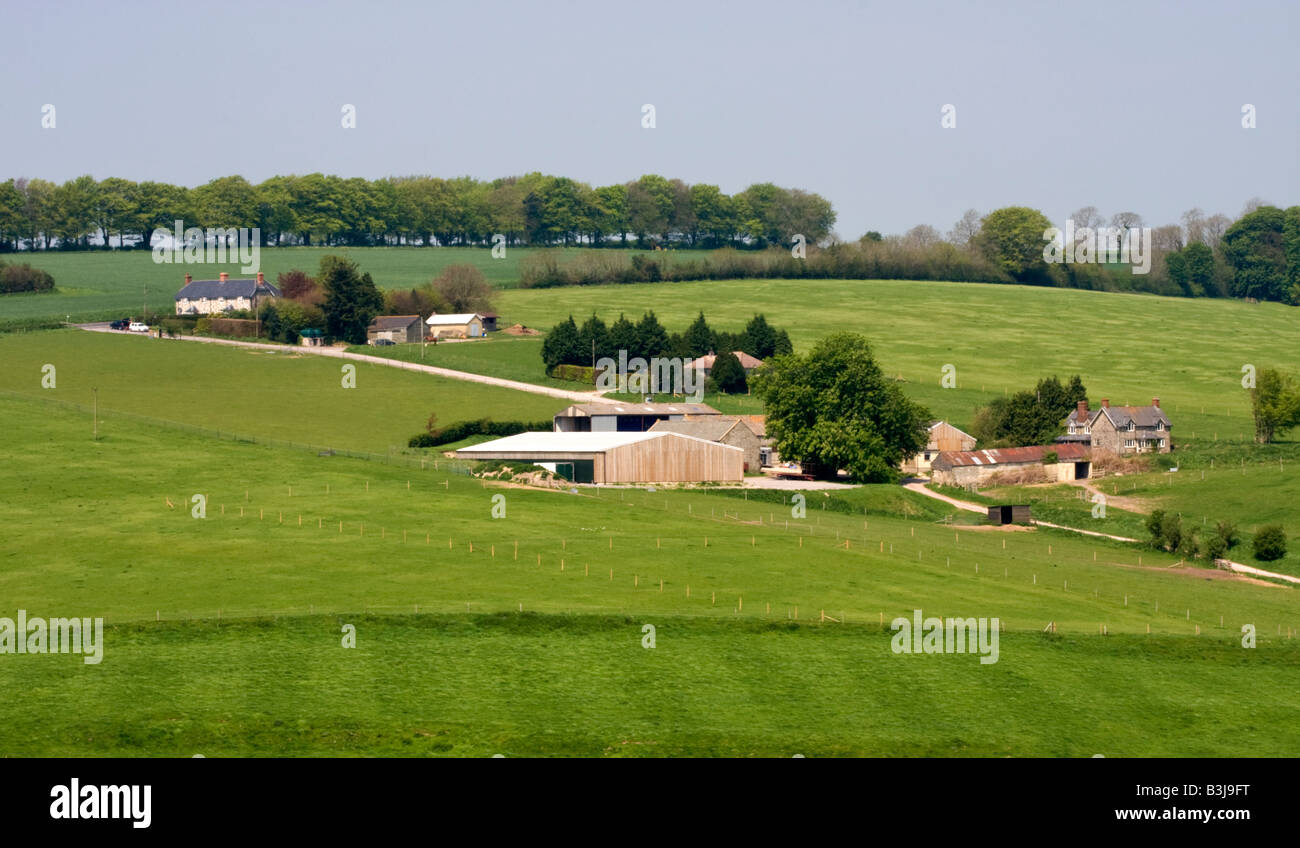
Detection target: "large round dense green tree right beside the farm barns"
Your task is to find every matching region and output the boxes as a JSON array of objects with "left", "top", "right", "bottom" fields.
[{"left": 750, "top": 333, "right": 930, "bottom": 483}]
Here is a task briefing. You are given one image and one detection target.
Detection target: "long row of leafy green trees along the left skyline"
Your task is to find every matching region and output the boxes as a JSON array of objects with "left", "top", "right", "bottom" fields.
[{"left": 0, "top": 173, "right": 835, "bottom": 250}]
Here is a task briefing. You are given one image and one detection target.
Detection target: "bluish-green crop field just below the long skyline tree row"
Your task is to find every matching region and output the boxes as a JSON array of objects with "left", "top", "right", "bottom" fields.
[{"left": 0, "top": 247, "right": 631, "bottom": 328}]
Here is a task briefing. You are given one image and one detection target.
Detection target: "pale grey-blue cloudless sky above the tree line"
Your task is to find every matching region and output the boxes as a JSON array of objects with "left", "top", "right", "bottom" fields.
[{"left": 0, "top": 0, "right": 1300, "bottom": 239}]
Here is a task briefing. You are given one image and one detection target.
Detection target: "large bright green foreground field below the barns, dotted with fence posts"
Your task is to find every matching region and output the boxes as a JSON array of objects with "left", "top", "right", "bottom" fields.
[{"left": 0, "top": 398, "right": 1300, "bottom": 756}]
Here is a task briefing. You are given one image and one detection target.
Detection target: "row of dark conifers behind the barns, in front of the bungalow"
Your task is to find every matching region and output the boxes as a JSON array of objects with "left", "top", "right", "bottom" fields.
[{"left": 542, "top": 311, "right": 793, "bottom": 376}]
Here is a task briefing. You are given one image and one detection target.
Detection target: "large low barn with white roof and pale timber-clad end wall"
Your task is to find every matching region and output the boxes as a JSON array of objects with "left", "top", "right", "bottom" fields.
[{"left": 456, "top": 432, "right": 745, "bottom": 484}]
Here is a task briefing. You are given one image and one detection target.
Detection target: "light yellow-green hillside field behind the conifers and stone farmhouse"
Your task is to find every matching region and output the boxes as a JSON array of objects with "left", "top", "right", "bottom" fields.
[{"left": 499, "top": 280, "right": 1300, "bottom": 442}]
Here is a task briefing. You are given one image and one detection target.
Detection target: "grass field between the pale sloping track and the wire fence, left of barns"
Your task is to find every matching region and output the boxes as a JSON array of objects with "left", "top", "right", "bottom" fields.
[{"left": 0, "top": 329, "right": 564, "bottom": 453}]
